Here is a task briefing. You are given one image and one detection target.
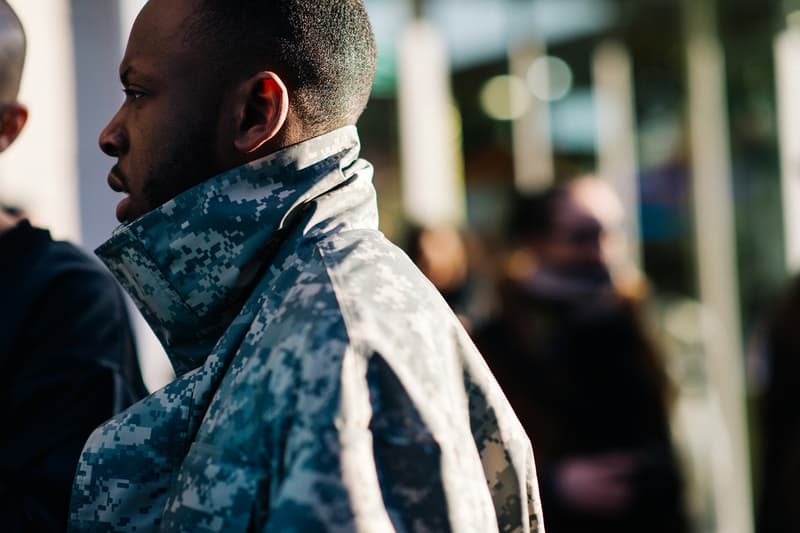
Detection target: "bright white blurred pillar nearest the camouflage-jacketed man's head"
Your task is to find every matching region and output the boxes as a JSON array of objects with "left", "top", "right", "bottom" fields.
[{"left": 398, "top": 20, "right": 466, "bottom": 226}]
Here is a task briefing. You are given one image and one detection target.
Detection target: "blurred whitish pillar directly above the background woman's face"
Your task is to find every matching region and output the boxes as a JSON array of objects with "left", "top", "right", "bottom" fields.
[{"left": 592, "top": 41, "right": 642, "bottom": 270}]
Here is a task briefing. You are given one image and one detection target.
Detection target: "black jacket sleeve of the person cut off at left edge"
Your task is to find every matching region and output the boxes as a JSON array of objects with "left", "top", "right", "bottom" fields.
[{"left": 0, "top": 269, "right": 138, "bottom": 532}]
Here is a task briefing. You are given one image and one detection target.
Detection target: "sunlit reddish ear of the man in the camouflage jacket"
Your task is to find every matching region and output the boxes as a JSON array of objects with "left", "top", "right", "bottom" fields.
[{"left": 234, "top": 72, "right": 289, "bottom": 154}]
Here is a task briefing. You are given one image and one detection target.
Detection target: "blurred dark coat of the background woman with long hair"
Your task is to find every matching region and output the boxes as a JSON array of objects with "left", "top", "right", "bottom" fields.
[{"left": 475, "top": 272, "right": 686, "bottom": 533}]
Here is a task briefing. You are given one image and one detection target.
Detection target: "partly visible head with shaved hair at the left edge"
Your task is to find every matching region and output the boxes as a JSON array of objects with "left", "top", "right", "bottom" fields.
[{"left": 0, "top": 1, "right": 28, "bottom": 156}]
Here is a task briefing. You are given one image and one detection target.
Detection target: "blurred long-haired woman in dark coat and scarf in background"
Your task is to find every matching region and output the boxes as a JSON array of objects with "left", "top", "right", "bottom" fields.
[{"left": 475, "top": 180, "right": 687, "bottom": 533}]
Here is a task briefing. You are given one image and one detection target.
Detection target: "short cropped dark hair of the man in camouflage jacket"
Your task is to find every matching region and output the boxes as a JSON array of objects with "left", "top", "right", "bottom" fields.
[{"left": 187, "top": 0, "right": 377, "bottom": 134}]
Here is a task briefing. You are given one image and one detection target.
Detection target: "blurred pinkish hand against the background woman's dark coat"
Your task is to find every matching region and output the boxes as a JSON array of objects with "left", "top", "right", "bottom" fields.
[{"left": 556, "top": 453, "right": 639, "bottom": 515}]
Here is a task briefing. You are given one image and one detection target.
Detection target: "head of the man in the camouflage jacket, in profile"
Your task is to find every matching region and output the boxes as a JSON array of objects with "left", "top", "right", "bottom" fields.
[{"left": 100, "top": 0, "right": 376, "bottom": 221}]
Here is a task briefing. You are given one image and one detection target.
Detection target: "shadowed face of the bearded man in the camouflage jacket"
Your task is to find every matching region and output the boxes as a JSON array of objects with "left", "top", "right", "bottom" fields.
[{"left": 100, "top": 0, "right": 236, "bottom": 222}]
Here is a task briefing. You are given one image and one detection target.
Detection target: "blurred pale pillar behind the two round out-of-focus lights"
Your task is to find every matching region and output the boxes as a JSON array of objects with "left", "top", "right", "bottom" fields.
[{"left": 509, "top": 42, "right": 555, "bottom": 193}]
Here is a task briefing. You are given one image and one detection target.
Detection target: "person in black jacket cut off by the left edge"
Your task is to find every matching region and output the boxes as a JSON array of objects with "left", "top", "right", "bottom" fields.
[{"left": 0, "top": 2, "right": 145, "bottom": 533}]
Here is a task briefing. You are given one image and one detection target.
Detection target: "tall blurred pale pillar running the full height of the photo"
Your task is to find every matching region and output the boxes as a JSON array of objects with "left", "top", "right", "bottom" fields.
[{"left": 683, "top": 0, "right": 753, "bottom": 533}]
